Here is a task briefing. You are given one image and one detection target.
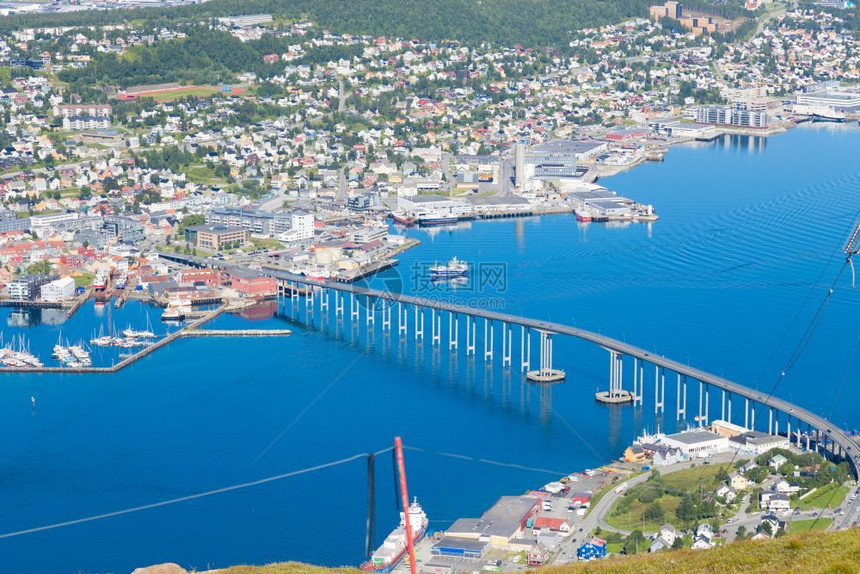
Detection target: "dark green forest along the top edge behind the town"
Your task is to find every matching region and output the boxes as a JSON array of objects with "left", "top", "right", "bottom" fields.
[{"left": 0, "top": 0, "right": 649, "bottom": 46}]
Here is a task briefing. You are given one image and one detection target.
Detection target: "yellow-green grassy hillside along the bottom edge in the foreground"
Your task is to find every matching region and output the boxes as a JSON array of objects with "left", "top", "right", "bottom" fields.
[{"left": 208, "top": 528, "right": 860, "bottom": 574}]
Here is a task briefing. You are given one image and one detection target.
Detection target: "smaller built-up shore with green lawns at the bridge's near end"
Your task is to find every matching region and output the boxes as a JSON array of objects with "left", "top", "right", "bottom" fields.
[{"left": 399, "top": 419, "right": 860, "bottom": 574}]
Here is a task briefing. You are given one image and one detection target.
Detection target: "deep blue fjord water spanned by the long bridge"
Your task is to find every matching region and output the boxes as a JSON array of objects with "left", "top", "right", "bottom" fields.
[{"left": 0, "top": 124, "right": 860, "bottom": 573}]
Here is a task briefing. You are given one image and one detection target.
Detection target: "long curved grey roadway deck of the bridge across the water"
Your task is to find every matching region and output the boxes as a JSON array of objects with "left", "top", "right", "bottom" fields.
[{"left": 262, "top": 267, "right": 860, "bottom": 479}]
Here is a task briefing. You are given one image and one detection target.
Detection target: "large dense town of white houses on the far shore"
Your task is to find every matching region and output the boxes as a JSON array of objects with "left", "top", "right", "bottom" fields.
[{"left": 0, "top": 2, "right": 860, "bottom": 328}]
